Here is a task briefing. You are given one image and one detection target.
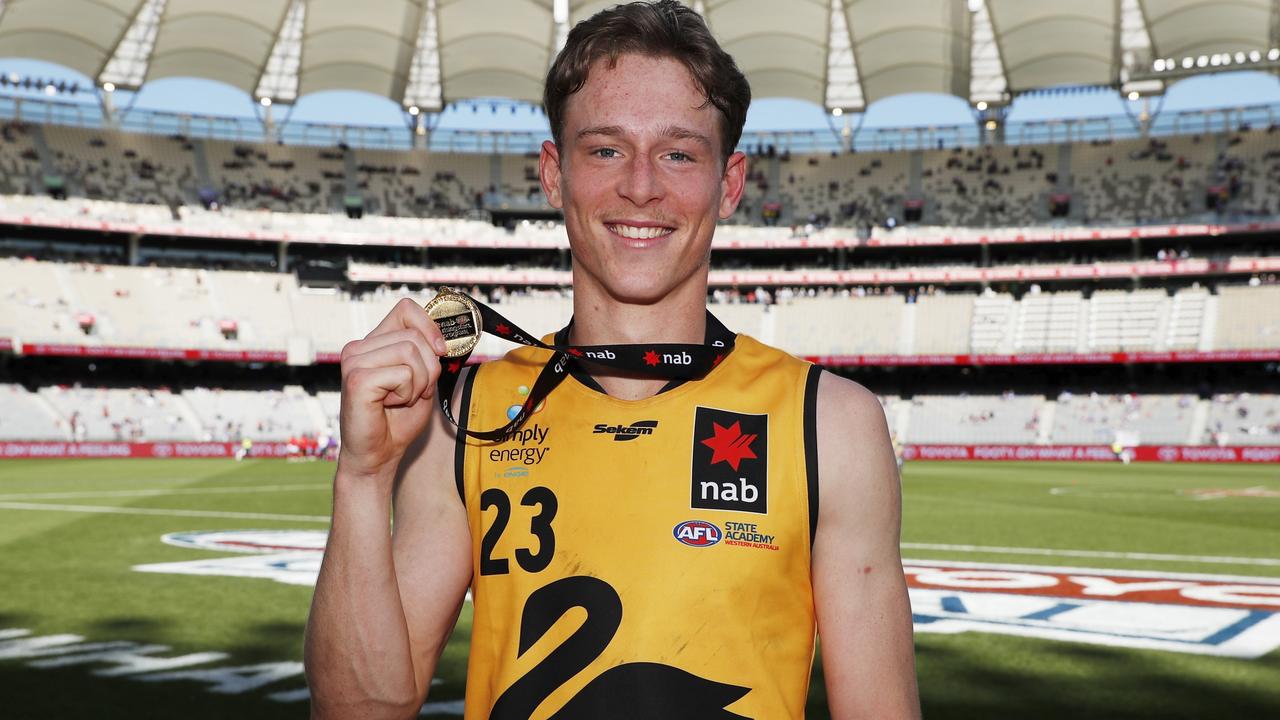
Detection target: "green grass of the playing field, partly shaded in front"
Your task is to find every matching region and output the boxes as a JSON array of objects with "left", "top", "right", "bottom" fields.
[{"left": 0, "top": 460, "right": 1280, "bottom": 720}]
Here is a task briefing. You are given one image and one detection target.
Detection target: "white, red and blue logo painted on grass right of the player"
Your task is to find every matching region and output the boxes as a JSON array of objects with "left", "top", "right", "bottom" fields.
[{"left": 902, "top": 560, "right": 1280, "bottom": 657}]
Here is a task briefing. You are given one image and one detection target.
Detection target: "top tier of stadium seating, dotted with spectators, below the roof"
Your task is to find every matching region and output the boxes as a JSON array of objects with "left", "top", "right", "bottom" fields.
[{"left": 0, "top": 113, "right": 1280, "bottom": 225}]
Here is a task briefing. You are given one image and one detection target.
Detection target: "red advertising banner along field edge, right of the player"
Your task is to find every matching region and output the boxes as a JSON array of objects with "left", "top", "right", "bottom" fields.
[{"left": 902, "top": 445, "right": 1280, "bottom": 462}]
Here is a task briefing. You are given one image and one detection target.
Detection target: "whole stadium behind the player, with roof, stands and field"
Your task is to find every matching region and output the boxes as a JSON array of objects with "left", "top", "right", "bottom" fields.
[{"left": 0, "top": 0, "right": 1280, "bottom": 717}]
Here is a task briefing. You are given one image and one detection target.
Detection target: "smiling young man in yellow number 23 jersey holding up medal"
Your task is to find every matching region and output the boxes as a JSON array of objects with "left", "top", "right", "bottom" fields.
[{"left": 306, "top": 0, "right": 919, "bottom": 720}]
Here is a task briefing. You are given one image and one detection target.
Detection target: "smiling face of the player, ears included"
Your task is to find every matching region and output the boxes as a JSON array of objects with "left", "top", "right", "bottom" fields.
[{"left": 540, "top": 54, "right": 746, "bottom": 305}]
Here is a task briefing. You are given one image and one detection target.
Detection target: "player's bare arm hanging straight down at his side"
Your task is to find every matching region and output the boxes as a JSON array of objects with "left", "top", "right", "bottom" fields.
[{"left": 813, "top": 373, "right": 920, "bottom": 720}]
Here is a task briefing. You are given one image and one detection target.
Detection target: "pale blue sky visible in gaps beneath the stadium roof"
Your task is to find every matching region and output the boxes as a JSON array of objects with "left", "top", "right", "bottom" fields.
[{"left": 0, "top": 58, "right": 1280, "bottom": 132}]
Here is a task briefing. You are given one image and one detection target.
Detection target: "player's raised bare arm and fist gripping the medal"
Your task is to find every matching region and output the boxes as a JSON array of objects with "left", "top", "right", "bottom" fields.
[{"left": 305, "top": 302, "right": 471, "bottom": 717}]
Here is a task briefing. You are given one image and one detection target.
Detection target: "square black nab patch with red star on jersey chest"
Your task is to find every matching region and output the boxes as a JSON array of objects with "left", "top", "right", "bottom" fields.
[{"left": 689, "top": 407, "right": 769, "bottom": 514}]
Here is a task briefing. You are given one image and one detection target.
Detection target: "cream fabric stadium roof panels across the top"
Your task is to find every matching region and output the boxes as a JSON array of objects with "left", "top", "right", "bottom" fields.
[{"left": 0, "top": 0, "right": 1280, "bottom": 110}]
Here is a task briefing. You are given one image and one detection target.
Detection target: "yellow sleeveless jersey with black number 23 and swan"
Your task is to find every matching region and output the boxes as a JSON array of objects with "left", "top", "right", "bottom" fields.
[{"left": 454, "top": 326, "right": 818, "bottom": 720}]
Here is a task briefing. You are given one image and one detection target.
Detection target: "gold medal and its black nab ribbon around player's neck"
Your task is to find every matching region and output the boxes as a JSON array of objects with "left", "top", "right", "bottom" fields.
[{"left": 426, "top": 287, "right": 733, "bottom": 441}]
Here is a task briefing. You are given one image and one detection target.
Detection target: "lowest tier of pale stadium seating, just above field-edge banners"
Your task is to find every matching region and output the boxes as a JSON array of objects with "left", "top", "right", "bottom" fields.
[{"left": 0, "top": 384, "right": 1259, "bottom": 446}]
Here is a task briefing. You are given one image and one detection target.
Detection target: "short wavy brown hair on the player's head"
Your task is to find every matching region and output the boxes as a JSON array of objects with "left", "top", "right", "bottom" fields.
[{"left": 543, "top": 0, "right": 751, "bottom": 163}]
